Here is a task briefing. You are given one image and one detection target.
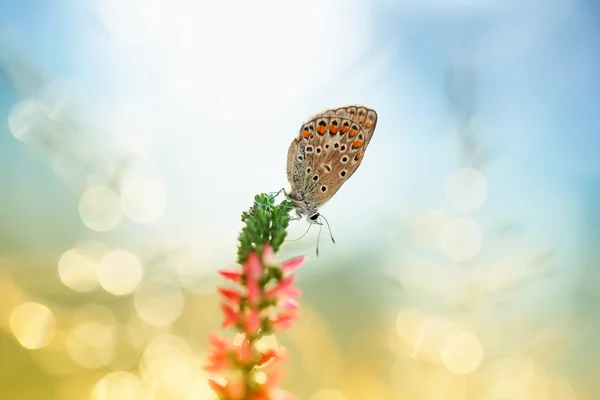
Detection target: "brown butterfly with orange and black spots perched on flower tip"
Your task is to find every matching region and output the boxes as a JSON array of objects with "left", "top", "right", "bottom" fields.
[{"left": 286, "top": 106, "right": 377, "bottom": 252}]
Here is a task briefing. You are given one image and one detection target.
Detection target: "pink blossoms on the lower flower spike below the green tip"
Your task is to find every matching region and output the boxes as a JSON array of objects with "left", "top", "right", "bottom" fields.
[{"left": 205, "top": 244, "right": 304, "bottom": 400}]
